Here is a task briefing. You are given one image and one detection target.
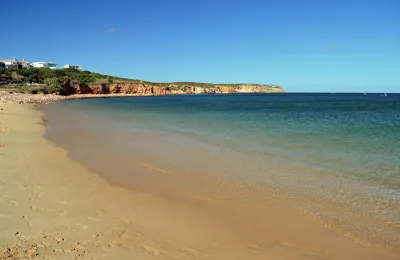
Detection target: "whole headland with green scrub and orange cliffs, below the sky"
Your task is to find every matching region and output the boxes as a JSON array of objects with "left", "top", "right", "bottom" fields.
[{"left": 0, "top": 68, "right": 284, "bottom": 95}]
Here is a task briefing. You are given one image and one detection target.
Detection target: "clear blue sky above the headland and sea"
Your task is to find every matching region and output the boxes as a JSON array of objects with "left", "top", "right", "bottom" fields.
[{"left": 0, "top": 0, "right": 400, "bottom": 92}]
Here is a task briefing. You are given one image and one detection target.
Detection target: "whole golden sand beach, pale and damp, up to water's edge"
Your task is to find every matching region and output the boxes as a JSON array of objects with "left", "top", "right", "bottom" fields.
[{"left": 0, "top": 104, "right": 400, "bottom": 260}]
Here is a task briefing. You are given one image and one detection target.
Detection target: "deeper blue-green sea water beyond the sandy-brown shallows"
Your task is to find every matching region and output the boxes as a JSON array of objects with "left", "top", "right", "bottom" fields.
[{"left": 53, "top": 94, "right": 400, "bottom": 188}]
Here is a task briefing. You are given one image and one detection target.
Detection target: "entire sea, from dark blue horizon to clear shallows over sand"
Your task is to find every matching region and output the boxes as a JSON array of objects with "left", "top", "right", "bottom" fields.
[{"left": 39, "top": 93, "right": 400, "bottom": 247}]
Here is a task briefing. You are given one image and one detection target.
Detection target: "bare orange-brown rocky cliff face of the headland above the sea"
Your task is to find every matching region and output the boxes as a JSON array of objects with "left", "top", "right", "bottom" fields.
[{"left": 63, "top": 82, "right": 284, "bottom": 96}]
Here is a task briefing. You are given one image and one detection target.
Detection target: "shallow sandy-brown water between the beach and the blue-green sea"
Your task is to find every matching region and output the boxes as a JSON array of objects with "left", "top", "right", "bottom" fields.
[{"left": 39, "top": 99, "right": 399, "bottom": 248}]
